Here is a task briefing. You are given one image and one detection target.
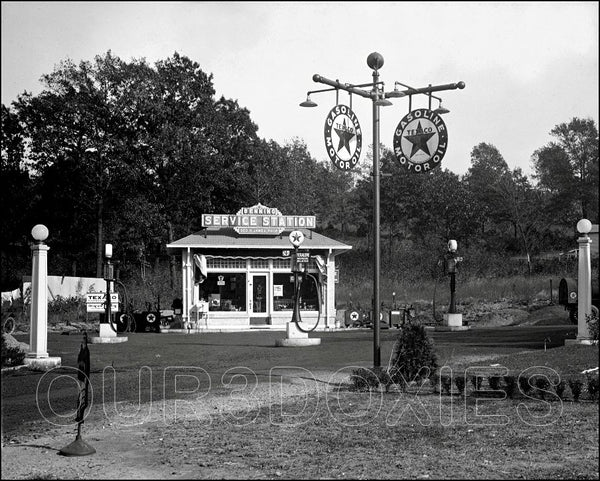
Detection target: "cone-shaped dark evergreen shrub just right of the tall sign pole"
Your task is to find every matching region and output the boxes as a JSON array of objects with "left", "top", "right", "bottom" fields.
[{"left": 390, "top": 323, "right": 437, "bottom": 388}]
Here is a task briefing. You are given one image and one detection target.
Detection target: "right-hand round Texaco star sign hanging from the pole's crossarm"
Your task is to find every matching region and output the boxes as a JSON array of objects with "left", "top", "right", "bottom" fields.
[{"left": 394, "top": 109, "right": 448, "bottom": 172}]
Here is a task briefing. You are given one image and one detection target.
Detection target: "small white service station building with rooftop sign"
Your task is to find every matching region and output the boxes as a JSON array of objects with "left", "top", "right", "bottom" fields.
[{"left": 167, "top": 204, "right": 352, "bottom": 331}]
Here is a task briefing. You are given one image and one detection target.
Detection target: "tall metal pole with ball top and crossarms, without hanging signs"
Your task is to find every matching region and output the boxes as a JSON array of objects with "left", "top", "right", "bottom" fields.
[{"left": 300, "top": 52, "right": 465, "bottom": 367}]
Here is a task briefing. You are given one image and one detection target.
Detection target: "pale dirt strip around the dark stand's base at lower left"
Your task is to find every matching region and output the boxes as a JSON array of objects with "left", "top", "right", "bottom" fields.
[{"left": 2, "top": 372, "right": 342, "bottom": 479}]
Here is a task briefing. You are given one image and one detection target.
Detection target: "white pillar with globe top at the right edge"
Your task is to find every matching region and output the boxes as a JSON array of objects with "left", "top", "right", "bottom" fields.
[{"left": 577, "top": 219, "right": 592, "bottom": 341}]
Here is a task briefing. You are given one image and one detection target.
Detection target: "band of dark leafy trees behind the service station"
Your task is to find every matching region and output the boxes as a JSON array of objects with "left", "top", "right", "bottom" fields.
[{"left": 0, "top": 51, "right": 599, "bottom": 290}]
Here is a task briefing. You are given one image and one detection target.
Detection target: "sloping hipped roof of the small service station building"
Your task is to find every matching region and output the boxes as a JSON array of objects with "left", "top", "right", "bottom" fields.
[{"left": 167, "top": 227, "right": 352, "bottom": 254}]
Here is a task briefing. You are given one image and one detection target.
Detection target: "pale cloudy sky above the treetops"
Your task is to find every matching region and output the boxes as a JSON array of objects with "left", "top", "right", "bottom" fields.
[{"left": 2, "top": 1, "right": 599, "bottom": 174}]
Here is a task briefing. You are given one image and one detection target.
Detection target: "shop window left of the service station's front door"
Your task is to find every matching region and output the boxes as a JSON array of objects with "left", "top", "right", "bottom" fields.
[{"left": 199, "top": 272, "right": 246, "bottom": 311}]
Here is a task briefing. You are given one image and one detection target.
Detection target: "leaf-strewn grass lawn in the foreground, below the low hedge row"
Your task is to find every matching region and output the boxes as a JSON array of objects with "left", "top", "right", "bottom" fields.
[{"left": 147, "top": 391, "right": 598, "bottom": 479}]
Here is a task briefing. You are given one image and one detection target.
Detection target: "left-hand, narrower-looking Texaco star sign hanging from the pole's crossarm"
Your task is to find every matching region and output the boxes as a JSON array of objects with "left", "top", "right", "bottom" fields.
[{"left": 325, "top": 105, "right": 362, "bottom": 170}]
